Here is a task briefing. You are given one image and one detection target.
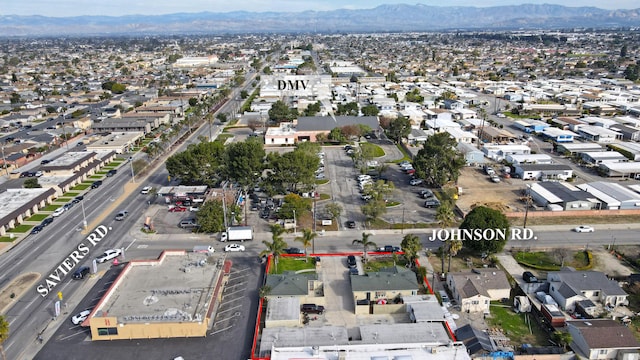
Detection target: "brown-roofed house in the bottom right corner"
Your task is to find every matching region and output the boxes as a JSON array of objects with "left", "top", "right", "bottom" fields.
[{"left": 567, "top": 319, "right": 640, "bottom": 360}]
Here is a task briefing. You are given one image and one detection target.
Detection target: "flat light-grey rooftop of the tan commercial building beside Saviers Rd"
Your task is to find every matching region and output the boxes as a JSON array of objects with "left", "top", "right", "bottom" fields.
[{"left": 95, "top": 250, "right": 223, "bottom": 323}]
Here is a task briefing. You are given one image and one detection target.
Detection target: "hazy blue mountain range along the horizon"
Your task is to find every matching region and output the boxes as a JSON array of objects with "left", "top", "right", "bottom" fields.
[{"left": 0, "top": 4, "right": 640, "bottom": 37}]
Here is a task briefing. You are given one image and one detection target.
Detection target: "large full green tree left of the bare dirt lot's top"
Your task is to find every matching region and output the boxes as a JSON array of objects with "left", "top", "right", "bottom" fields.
[{"left": 413, "top": 132, "right": 466, "bottom": 187}]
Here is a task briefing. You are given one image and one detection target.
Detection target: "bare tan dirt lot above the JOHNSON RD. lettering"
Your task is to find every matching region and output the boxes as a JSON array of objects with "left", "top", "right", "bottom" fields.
[{"left": 456, "top": 166, "right": 525, "bottom": 213}]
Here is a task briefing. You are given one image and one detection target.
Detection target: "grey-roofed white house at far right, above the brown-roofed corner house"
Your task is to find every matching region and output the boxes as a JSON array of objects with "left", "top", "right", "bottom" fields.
[{"left": 547, "top": 270, "right": 629, "bottom": 312}]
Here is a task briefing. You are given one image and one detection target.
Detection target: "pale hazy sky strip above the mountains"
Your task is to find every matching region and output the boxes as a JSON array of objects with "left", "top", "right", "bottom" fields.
[{"left": 0, "top": 0, "right": 640, "bottom": 17}]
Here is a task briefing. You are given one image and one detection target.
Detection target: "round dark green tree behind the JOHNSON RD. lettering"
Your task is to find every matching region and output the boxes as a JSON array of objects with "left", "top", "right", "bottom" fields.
[{"left": 460, "top": 206, "right": 509, "bottom": 254}]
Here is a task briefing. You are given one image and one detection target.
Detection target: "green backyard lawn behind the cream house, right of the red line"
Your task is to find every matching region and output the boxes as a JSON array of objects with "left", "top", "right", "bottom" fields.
[{"left": 487, "top": 303, "right": 547, "bottom": 347}]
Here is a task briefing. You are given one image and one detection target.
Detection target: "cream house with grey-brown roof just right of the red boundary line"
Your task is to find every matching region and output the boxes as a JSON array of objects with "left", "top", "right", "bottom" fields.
[{"left": 446, "top": 269, "right": 511, "bottom": 313}]
